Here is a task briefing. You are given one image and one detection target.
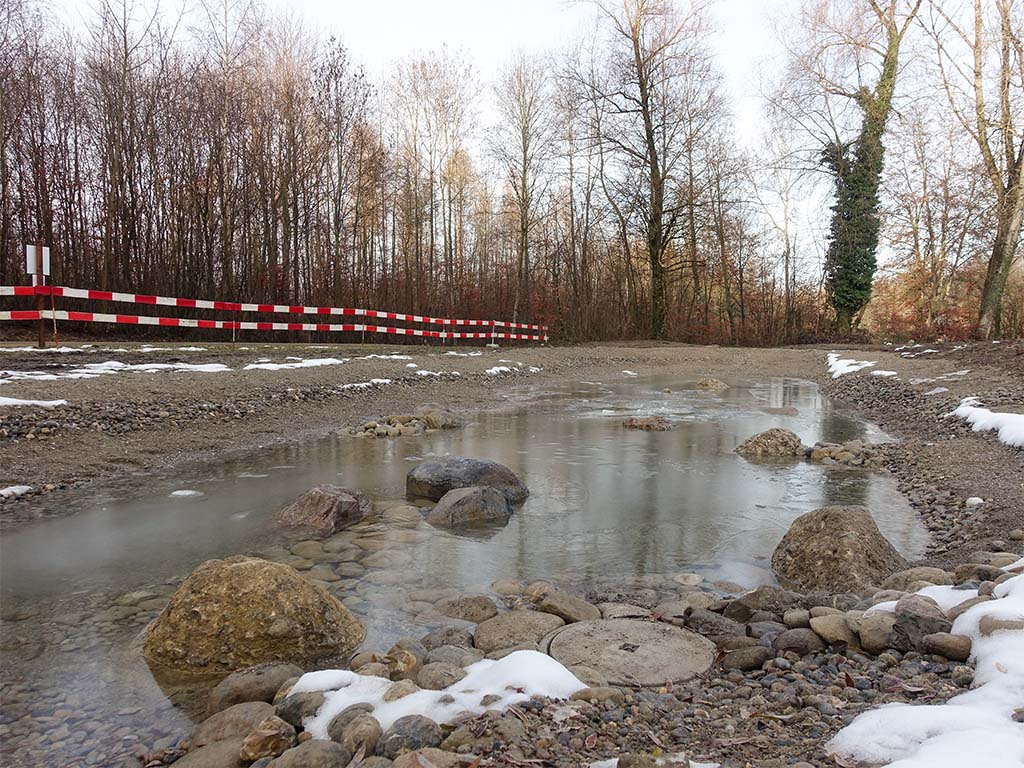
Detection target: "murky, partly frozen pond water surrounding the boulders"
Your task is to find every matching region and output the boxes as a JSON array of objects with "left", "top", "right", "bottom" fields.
[{"left": 0, "top": 378, "right": 926, "bottom": 765}]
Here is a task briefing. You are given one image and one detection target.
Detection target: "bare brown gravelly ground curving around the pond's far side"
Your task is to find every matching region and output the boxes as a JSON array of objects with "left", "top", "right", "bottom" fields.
[{"left": 0, "top": 343, "right": 1024, "bottom": 563}]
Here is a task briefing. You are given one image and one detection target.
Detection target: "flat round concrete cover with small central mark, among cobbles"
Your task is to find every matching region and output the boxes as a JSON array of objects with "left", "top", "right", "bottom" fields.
[{"left": 549, "top": 618, "right": 715, "bottom": 687}]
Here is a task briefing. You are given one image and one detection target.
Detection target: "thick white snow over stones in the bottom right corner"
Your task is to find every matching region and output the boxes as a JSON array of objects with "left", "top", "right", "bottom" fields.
[{"left": 826, "top": 577, "right": 1024, "bottom": 768}]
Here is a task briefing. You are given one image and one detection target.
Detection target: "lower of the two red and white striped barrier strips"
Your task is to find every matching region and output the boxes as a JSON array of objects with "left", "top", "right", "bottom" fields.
[{"left": 0, "top": 309, "right": 548, "bottom": 341}]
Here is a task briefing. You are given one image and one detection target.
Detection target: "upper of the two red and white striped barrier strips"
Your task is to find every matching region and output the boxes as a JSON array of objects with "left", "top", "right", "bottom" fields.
[{"left": 0, "top": 286, "right": 548, "bottom": 331}]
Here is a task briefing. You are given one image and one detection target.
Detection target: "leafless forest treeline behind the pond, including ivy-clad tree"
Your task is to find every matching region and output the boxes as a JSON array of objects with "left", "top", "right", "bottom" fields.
[{"left": 0, "top": 0, "right": 1024, "bottom": 344}]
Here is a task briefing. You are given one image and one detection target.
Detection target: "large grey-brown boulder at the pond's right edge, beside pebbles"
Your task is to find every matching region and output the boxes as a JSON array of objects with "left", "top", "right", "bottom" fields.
[{"left": 771, "top": 507, "right": 906, "bottom": 592}]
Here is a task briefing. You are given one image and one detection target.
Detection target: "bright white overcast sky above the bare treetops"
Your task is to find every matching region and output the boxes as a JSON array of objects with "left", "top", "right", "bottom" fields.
[{"left": 54, "top": 0, "right": 800, "bottom": 144}]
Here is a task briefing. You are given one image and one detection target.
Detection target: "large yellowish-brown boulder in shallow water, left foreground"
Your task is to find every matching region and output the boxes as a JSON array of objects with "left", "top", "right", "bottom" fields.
[{"left": 142, "top": 555, "right": 366, "bottom": 677}]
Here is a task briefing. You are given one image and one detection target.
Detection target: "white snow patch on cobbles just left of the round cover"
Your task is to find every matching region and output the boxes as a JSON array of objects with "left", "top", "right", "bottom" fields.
[{"left": 292, "top": 650, "right": 587, "bottom": 738}]
